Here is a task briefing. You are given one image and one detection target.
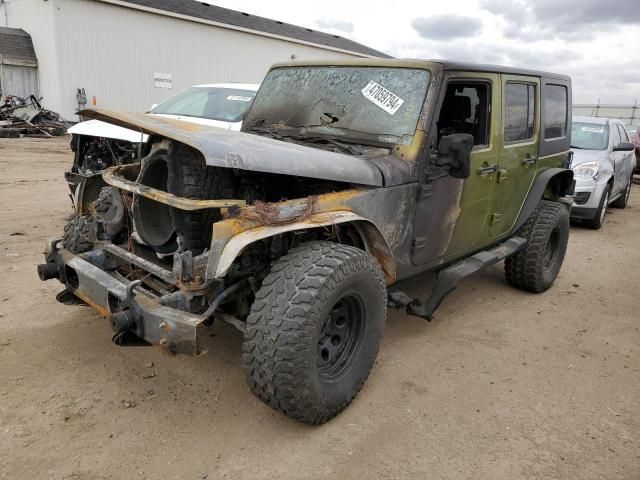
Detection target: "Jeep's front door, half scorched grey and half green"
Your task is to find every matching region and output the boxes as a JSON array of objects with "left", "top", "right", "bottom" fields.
[{"left": 412, "top": 72, "right": 501, "bottom": 265}]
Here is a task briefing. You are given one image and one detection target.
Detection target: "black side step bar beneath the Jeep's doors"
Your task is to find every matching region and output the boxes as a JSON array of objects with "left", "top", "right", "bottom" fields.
[{"left": 389, "top": 237, "right": 527, "bottom": 321}]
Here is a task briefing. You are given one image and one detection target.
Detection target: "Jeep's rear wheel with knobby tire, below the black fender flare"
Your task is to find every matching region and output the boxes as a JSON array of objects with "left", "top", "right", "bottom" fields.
[{"left": 504, "top": 200, "right": 569, "bottom": 293}]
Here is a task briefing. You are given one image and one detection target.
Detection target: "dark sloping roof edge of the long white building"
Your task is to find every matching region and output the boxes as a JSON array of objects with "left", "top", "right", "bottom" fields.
[{"left": 110, "top": 0, "right": 389, "bottom": 58}]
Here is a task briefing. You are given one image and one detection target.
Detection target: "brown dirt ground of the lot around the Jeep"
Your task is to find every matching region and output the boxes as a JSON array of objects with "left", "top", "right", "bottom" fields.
[{"left": 0, "top": 139, "right": 640, "bottom": 480}]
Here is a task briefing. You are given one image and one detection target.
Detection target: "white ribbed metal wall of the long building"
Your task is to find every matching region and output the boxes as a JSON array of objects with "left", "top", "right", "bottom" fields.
[{"left": 10, "top": 0, "right": 356, "bottom": 119}]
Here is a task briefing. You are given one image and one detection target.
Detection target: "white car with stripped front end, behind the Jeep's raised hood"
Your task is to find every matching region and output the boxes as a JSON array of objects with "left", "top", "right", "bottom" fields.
[{"left": 65, "top": 83, "right": 259, "bottom": 210}]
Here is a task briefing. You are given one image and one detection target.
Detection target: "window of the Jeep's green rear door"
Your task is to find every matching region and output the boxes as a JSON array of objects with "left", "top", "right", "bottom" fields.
[{"left": 504, "top": 82, "right": 536, "bottom": 143}]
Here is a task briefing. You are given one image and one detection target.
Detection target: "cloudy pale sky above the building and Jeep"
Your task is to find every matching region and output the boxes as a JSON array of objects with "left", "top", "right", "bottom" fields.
[{"left": 208, "top": 0, "right": 640, "bottom": 104}]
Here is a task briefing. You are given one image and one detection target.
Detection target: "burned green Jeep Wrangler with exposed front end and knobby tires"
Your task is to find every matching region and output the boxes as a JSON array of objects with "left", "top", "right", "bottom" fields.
[{"left": 38, "top": 60, "right": 573, "bottom": 424}]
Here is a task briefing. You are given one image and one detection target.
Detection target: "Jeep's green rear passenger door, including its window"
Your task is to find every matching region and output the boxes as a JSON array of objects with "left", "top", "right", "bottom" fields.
[{"left": 489, "top": 75, "right": 540, "bottom": 237}]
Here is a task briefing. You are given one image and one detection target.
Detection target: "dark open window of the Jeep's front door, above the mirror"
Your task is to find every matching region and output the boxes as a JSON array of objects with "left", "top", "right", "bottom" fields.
[{"left": 437, "top": 82, "right": 490, "bottom": 146}]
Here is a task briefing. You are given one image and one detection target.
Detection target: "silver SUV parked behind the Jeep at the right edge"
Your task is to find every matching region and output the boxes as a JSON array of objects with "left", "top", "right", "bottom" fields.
[{"left": 571, "top": 117, "right": 636, "bottom": 229}]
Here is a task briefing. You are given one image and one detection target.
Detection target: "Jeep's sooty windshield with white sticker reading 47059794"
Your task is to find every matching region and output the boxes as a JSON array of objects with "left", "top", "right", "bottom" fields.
[{"left": 245, "top": 66, "right": 429, "bottom": 144}]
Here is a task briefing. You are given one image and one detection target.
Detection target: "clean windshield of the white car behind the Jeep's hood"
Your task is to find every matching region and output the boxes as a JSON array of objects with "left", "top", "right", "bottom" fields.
[{"left": 149, "top": 87, "right": 256, "bottom": 122}]
